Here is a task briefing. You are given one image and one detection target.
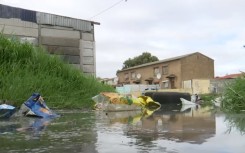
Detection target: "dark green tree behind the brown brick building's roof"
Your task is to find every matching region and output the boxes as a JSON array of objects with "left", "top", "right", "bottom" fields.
[{"left": 122, "top": 52, "right": 159, "bottom": 69}]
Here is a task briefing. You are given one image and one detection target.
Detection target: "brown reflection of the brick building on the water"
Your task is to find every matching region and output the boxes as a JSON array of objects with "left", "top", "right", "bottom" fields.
[{"left": 132, "top": 108, "right": 215, "bottom": 144}]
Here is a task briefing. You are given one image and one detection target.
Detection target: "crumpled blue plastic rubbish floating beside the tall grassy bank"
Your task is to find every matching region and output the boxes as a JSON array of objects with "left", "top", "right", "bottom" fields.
[{"left": 0, "top": 93, "right": 59, "bottom": 119}]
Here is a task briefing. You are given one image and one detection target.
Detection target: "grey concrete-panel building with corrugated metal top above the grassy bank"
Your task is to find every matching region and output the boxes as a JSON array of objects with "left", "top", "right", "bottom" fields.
[{"left": 0, "top": 4, "right": 99, "bottom": 75}]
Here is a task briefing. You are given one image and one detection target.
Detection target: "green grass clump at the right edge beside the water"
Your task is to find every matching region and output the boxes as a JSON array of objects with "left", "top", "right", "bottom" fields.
[{"left": 222, "top": 75, "right": 245, "bottom": 113}]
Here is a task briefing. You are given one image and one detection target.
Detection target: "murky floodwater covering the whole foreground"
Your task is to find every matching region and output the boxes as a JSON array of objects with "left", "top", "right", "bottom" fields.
[{"left": 0, "top": 107, "right": 245, "bottom": 153}]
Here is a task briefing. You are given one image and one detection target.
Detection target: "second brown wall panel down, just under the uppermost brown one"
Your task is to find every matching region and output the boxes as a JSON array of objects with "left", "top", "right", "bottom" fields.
[{"left": 44, "top": 45, "right": 80, "bottom": 56}]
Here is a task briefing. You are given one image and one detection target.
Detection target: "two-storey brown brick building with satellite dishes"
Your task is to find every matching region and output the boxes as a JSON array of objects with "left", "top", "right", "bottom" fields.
[{"left": 117, "top": 52, "right": 214, "bottom": 89}]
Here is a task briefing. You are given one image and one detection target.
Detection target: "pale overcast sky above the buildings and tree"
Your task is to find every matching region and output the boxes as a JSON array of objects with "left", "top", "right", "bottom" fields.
[{"left": 0, "top": 0, "right": 245, "bottom": 78}]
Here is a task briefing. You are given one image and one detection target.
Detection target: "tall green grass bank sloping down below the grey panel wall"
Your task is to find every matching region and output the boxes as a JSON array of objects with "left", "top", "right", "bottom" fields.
[{"left": 0, "top": 34, "right": 114, "bottom": 108}]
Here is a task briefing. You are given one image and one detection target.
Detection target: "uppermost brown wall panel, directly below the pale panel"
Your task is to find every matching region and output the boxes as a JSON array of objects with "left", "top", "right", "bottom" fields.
[{"left": 41, "top": 37, "right": 79, "bottom": 48}]
